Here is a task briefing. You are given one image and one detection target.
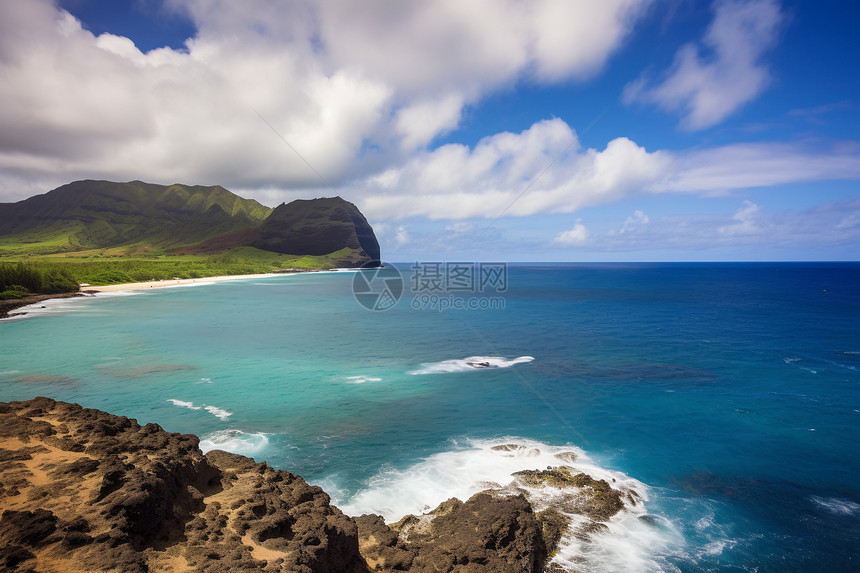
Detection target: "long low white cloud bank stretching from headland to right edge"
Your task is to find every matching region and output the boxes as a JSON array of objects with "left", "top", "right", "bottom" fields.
[{"left": 349, "top": 115, "right": 860, "bottom": 220}]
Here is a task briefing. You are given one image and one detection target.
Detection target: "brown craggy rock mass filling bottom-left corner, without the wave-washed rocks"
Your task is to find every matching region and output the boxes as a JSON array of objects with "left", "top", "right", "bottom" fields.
[{"left": 0, "top": 398, "right": 367, "bottom": 573}]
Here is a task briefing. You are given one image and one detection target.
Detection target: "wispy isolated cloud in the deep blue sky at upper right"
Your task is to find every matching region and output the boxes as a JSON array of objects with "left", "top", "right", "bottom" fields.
[{"left": 622, "top": 0, "right": 784, "bottom": 130}]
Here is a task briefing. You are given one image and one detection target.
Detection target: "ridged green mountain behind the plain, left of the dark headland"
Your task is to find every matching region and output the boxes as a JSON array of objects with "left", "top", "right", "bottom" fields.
[{"left": 0, "top": 180, "right": 271, "bottom": 254}]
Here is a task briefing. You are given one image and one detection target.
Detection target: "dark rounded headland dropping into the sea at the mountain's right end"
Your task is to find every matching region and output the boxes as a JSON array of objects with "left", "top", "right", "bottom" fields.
[{"left": 250, "top": 197, "right": 380, "bottom": 266}]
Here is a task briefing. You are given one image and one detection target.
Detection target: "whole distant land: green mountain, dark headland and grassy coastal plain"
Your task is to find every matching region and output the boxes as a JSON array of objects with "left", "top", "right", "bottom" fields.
[{"left": 0, "top": 181, "right": 379, "bottom": 300}]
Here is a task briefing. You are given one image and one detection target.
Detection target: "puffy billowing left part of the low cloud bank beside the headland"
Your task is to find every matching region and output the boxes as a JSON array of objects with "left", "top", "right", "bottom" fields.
[{"left": 359, "top": 119, "right": 672, "bottom": 219}]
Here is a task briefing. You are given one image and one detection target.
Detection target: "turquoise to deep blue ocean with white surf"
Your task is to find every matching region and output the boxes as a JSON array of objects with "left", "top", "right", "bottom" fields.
[{"left": 0, "top": 263, "right": 860, "bottom": 572}]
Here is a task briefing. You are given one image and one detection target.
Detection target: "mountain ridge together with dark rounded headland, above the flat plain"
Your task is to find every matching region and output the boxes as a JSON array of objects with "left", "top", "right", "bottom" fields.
[{"left": 0, "top": 180, "right": 379, "bottom": 266}]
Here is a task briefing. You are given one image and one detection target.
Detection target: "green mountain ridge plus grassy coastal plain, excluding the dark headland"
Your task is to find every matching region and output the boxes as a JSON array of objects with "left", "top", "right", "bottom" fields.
[{"left": 0, "top": 181, "right": 372, "bottom": 285}]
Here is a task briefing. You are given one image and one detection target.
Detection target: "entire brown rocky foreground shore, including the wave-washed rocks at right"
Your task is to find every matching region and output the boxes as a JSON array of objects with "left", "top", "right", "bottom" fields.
[{"left": 0, "top": 398, "right": 637, "bottom": 573}]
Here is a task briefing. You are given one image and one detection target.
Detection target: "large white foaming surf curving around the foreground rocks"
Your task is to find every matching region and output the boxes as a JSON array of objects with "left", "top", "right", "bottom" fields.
[{"left": 330, "top": 438, "right": 683, "bottom": 571}]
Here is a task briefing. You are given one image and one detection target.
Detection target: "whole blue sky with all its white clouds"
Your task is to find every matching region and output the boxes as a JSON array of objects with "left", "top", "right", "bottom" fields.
[{"left": 0, "top": 0, "right": 860, "bottom": 262}]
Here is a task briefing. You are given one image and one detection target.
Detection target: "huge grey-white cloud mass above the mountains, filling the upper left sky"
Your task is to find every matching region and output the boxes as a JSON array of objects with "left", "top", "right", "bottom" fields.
[{"left": 0, "top": 0, "right": 651, "bottom": 198}]
